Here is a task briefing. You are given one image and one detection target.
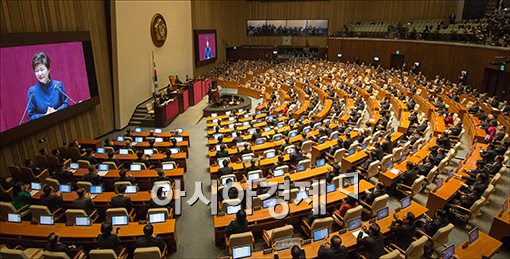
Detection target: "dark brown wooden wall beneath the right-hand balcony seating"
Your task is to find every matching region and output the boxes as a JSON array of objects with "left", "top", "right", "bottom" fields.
[{"left": 328, "top": 38, "right": 510, "bottom": 92}]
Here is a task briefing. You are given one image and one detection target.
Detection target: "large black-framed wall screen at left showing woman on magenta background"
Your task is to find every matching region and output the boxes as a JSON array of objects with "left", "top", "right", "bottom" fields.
[{"left": 0, "top": 32, "right": 99, "bottom": 144}]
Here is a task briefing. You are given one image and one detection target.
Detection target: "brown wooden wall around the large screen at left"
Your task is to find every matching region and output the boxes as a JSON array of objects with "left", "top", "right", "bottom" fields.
[{"left": 0, "top": 0, "right": 114, "bottom": 176}]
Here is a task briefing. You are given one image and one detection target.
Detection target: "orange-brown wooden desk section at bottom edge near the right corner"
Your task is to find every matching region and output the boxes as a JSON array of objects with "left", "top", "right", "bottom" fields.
[{"left": 455, "top": 231, "right": 503, "bottom": 259}]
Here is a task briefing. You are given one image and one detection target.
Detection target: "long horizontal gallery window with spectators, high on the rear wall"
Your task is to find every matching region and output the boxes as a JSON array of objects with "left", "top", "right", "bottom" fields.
[{"left": 246, "top": 20, "right": 328, "bottom": 37}]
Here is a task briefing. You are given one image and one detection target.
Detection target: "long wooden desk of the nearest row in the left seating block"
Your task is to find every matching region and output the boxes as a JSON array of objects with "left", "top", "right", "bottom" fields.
[{"left": 0, "top": 219, "right": 177, "bottom": 249}]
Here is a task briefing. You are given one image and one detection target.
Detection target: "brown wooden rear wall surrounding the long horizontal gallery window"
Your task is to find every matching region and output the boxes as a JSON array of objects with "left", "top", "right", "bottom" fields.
[{"left": 192, "top": 0, "right": 464, "bottom": 75}]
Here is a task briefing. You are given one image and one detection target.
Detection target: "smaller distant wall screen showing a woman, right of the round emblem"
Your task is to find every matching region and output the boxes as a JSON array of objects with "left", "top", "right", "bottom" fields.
[{"left": 193, "top": 30, "right": 217, "bottom": 66}]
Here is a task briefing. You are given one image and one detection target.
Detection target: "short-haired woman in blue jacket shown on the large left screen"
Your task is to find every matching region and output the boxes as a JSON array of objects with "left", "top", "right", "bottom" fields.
[{"left": 27, "top": 52, "right": 69, "bottom": 121}]
